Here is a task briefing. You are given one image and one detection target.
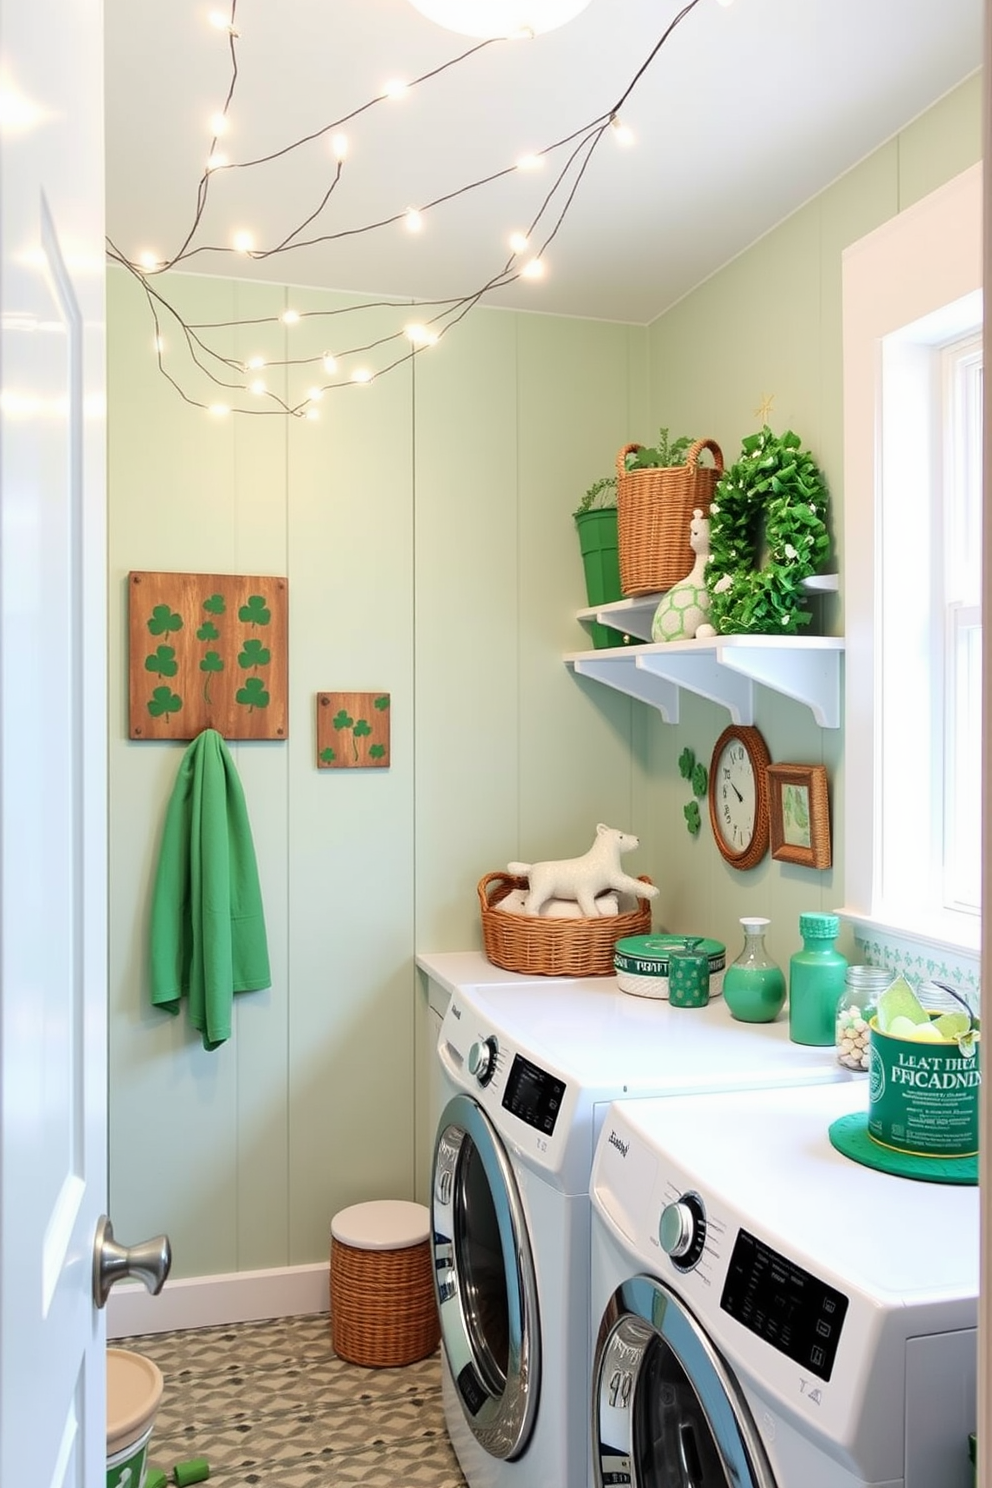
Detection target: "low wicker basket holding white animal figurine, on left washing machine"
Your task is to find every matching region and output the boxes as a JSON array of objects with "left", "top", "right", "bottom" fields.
[{"left": 479, "top": 873, "right": 651, "bottom": 976}]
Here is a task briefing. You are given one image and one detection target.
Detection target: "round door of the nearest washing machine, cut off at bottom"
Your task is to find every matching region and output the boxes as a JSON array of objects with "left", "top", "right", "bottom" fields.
[{"left": 592, "top": 1277, "right": 775, "bottom": 1488}]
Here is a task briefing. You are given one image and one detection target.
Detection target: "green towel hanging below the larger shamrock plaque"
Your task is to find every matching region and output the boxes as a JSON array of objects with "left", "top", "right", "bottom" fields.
[{"left": 152, "top": 729, "right": 272, "bottom": 1049}]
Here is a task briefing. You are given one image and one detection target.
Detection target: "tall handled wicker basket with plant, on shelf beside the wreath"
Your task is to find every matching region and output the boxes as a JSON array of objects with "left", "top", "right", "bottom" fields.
[{"left": 617, "top": 439, "right": 723, "bottom": 595}]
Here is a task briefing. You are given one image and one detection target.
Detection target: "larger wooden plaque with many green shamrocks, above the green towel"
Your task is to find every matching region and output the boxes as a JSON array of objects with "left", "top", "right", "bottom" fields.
[{"left": 128, "top": 573, "right": 289, "bottom": 740}]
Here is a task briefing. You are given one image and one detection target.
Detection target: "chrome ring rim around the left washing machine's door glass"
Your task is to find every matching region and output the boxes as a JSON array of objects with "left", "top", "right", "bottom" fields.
[{"left": 431, "top": 1095, "right": 541, "bottom": 1460}]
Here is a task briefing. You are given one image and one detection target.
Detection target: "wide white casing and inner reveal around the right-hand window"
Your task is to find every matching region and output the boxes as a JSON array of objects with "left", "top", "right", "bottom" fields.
[{"left": 843, "top": 165, "right": 982, "bottom": 951}]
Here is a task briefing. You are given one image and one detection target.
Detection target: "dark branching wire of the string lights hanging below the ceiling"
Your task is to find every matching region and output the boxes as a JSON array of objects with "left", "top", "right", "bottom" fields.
[{"left": 107, "top": 0, "right": 700, "bottom": 418}]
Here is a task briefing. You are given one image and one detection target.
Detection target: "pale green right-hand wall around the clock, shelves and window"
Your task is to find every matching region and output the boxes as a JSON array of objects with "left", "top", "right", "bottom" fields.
[{"left": 638, "top": 76, "right": 982, "bottom": 964}]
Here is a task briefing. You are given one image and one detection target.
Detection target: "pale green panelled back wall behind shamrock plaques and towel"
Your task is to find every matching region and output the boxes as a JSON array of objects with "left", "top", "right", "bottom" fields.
[{"left": 109, "top": 272, "right": 647, "bottom": 1275}]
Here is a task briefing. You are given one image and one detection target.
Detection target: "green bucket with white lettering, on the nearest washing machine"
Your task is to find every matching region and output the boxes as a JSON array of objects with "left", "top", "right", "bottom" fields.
[{"left": 869, "top": 1013, "right": 982, "bottom": 1158}]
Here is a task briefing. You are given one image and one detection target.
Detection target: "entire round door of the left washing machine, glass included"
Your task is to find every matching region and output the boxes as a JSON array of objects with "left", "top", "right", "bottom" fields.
[{"left": 431, "top": 1095, "right": 540, "bottom": 1461}]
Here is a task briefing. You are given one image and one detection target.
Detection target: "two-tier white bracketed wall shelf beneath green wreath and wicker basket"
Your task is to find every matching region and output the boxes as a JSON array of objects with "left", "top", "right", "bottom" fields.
[{"left": 565, "top": 633, "right": 845, "bottom": 729}]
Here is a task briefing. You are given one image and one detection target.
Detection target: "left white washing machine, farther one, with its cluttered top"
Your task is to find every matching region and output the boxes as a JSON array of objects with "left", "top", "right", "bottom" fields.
[{"left": 418, "top": 952, "right": 852, "bottom": 1488}]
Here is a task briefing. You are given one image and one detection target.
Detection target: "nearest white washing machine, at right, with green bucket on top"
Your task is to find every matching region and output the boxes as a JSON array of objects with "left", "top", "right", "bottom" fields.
[{"left": 590, "top": 1082, "right": 979, "bottom": 1488}]
